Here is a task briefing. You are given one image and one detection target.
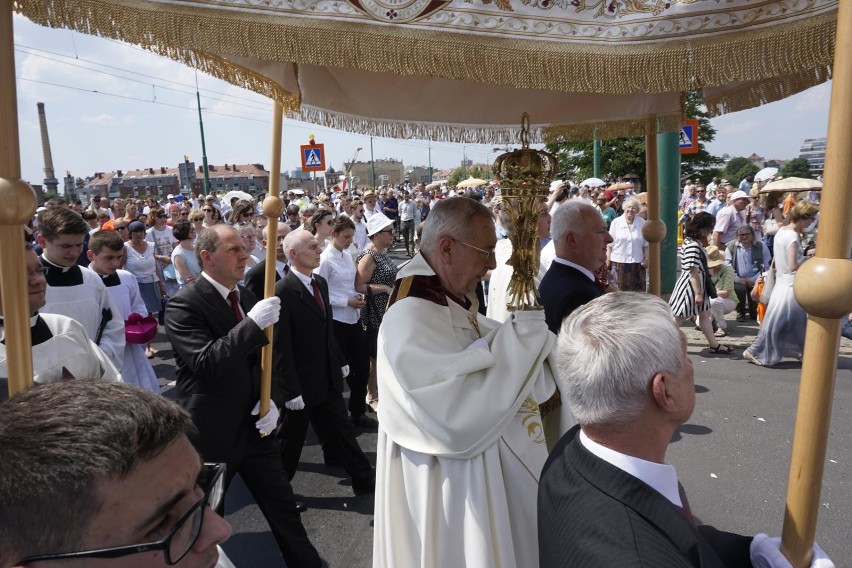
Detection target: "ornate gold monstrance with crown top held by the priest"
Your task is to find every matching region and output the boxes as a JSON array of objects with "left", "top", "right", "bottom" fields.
[{"left": 492, "top": 113, "right": 557, "bottom": 311}]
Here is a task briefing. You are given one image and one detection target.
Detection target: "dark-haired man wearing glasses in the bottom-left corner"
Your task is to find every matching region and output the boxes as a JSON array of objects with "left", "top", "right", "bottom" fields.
[{"left": 0, "top": 380, "right": 233, "bottom": 568}]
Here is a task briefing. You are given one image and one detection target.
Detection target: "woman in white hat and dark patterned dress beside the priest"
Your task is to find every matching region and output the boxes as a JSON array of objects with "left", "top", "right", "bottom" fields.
[{"left": 352, "top": 213, "right": 397, "bottom": 411}]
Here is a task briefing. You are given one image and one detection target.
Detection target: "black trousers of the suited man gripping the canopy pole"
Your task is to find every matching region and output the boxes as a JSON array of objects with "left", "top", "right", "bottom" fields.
[{"left": 217, "top": 436, "right": 322, "bottom": 567}]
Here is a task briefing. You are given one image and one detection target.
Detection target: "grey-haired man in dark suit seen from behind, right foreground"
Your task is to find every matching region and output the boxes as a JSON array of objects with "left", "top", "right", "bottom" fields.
[{"left": 538, "top": 292, "right": 830, "bottom": 568}]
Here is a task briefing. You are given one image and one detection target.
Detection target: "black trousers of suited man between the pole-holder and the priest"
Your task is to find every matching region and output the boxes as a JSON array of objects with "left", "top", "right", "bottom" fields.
[{"left": 275, "top": 391, "right": 376, "bottom": 487}]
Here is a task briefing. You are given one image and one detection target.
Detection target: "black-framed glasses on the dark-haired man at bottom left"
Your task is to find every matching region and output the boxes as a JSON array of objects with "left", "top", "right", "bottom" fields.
[{"left": 18, "top": 463, "right": 225, "bottom": 566}]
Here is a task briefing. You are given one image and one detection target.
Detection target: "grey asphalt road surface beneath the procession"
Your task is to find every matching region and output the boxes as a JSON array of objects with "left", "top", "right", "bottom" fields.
[{"left": 146, "top": 239, "right": 852, "bottom": 568}]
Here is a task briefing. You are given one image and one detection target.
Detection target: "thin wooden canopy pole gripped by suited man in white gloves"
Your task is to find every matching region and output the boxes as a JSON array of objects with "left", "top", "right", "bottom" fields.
[{"left": 260, "top": 101, "right": 284, "bottom": 416}]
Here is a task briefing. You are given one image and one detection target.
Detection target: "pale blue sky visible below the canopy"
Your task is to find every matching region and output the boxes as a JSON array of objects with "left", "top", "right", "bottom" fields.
[{"left": 14, "top": 15, "right": 830, "bottom": 183}]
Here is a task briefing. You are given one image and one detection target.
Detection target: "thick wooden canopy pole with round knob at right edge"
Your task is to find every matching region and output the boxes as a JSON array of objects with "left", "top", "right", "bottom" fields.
[{"left": 781, "top": 2, "right": 852, "bottom": 568}]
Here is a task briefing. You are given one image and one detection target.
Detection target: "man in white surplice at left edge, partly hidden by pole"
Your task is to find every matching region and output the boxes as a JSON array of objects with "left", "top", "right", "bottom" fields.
[{"left": 0, "top": 242, "right": 123, "bottom": 398}]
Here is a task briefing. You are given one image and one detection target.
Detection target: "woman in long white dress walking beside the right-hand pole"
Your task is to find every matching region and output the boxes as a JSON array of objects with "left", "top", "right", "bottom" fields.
[{"left": 743, "top": 201, "right": 819, "bottom": 366}]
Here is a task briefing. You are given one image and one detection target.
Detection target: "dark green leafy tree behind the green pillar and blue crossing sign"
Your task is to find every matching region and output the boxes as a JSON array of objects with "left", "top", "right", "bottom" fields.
[{"left": 547, "top": 92, "right": 721, "bottom": 183}]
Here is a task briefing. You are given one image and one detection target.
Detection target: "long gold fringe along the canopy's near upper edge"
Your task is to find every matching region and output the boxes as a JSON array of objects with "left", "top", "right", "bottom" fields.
[{"left": 16, "top": 0, "right": 837, "bottom": 96}]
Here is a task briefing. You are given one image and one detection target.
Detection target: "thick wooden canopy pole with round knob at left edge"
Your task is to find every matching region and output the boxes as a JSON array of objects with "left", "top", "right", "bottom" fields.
[{"left": 0, "top": 0, "right": 36, "bottom": 396}]
